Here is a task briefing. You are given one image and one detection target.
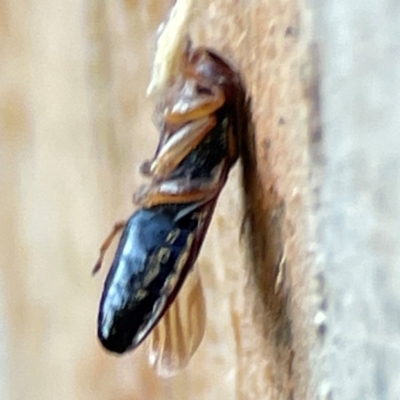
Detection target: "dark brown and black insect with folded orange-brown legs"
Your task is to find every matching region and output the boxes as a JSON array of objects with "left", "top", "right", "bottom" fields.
[{"left": 94, "top": 46, "right": 244, "bottom": 376}]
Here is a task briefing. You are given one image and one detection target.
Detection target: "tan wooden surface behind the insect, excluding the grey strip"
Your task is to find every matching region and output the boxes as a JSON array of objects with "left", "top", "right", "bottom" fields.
[{"left": 0, "top": 0, "right": 316, "bottom": 400}]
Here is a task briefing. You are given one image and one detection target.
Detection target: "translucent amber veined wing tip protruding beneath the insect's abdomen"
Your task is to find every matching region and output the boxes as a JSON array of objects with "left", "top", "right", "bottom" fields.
[{"left": 146, "top": 269, "right": 206, "bottom": 377}]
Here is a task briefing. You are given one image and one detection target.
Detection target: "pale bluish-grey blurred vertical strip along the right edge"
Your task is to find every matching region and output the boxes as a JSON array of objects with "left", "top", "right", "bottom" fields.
[{"left": 316, "top": 0, "right": 400, "bottom": 400}]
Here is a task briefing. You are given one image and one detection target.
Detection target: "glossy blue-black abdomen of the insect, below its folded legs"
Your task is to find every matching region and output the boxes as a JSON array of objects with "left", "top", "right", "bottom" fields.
[{"left": 98, "top": 203, "right": 213, "bottom": 353}]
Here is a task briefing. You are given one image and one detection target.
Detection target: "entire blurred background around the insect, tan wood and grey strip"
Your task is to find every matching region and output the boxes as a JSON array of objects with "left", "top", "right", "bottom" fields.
[{"left": 0, "top": 0, "right": 400, "bottom": 400}]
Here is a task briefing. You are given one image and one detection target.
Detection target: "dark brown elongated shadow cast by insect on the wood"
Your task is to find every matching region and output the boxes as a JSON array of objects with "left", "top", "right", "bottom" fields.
[{"left": 239, "top": 100, "right": 292, "bottom": 364}]
